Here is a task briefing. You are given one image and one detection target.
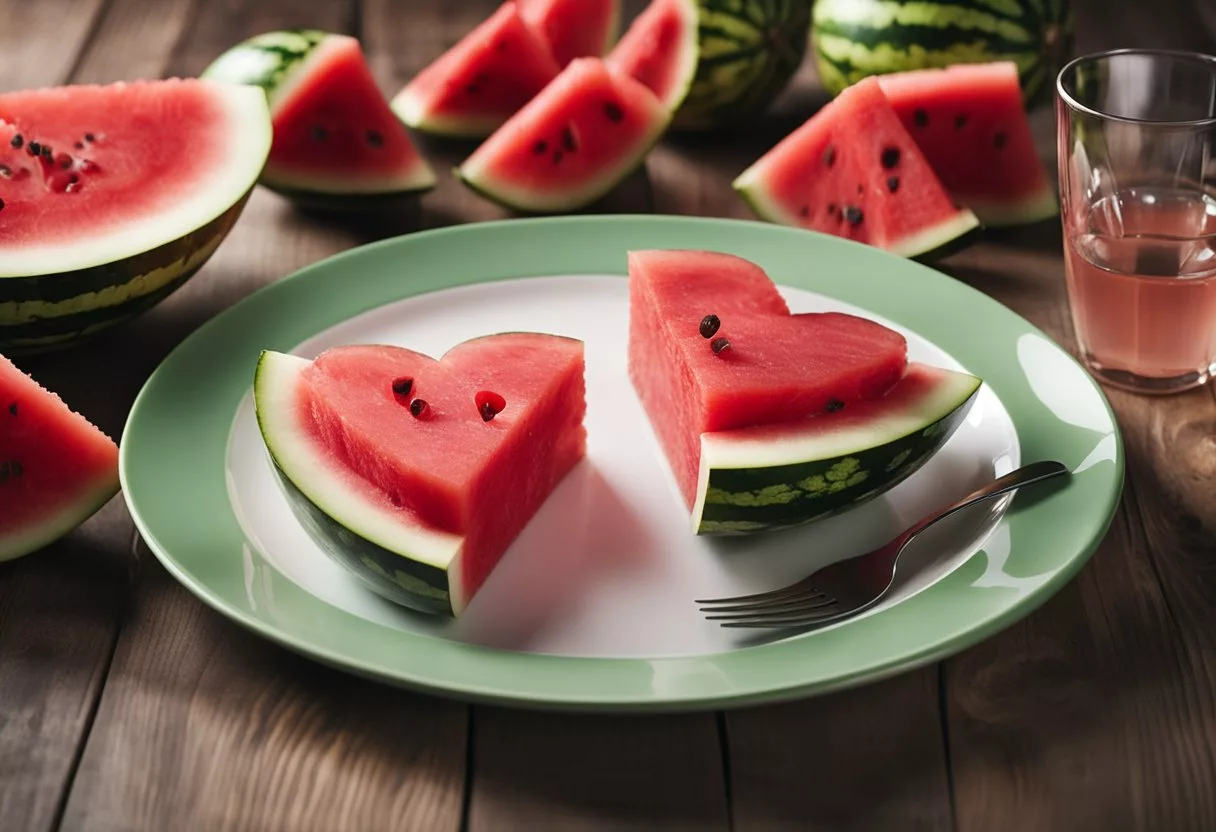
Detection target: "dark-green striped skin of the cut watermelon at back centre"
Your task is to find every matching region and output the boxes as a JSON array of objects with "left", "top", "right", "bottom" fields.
[{"left": 672, "top": 0, "right": 812, "bottom": 129}]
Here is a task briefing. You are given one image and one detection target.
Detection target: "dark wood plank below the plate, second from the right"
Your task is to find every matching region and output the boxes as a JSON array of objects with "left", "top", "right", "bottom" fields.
[{"left": 726, "top": 667, "right": 951, "bottom": 832}]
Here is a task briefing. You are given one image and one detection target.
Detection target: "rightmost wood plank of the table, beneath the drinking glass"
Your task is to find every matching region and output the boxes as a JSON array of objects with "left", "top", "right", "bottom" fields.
[{"left": 947, "top": 0, "right": 1216, "bottom": 832}]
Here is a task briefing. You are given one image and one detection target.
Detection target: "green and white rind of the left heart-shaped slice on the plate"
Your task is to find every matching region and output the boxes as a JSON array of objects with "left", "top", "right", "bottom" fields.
[{"left": 253, "top": 350, "right": 468, "bottom": 617}]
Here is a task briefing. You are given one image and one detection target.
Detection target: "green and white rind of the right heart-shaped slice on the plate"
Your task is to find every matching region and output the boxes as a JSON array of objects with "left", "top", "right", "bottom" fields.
[{"left": 691, "top": 367, "right": 983, "bottom": 535}]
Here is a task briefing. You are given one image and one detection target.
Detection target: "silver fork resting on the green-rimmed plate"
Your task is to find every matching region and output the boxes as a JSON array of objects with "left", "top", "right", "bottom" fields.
[{"left": 696, "top": 461, "right": 1068, "bottom": 628}]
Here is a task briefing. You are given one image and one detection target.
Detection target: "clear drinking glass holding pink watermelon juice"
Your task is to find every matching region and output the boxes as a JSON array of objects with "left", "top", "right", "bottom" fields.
[{"left": 1055, "top": 50, "right": 1216, "bottom": 393}]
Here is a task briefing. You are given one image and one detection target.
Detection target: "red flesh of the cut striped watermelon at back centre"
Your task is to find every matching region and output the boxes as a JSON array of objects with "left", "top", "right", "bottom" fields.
[{"left": 608, "top": 0, "right": 698, "bottom": 112}]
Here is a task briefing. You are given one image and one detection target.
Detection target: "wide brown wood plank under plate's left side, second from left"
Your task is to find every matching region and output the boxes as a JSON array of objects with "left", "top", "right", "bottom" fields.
[{"left": 53, "top": 0, "right": 467, "bottom": 832}]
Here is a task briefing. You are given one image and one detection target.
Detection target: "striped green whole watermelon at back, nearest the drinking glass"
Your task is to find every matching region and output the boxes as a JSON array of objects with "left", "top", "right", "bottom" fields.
[{"left": 812, "top": 0, "right": 1073, "bottom": 103}]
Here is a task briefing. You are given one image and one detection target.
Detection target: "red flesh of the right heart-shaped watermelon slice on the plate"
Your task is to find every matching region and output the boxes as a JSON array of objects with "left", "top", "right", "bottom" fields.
[{"left": 629, "top": 251, "right": 907, "bottom": 506}]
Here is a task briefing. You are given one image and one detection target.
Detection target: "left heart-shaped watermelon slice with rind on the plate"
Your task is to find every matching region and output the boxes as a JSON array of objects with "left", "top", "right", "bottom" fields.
[{"left": 254, "top": 333, "right": 586, "bottom": 615}]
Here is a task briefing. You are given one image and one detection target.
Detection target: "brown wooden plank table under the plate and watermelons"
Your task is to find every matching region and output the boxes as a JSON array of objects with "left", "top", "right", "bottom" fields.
[{"left": 0, "top": 0, "right": 1216, "bottom": 832}]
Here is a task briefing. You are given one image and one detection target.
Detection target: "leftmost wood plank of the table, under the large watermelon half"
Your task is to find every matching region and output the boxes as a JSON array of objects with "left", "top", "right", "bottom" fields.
[{"left": 0, "top": 0, "right": 190, "bottom": 832}]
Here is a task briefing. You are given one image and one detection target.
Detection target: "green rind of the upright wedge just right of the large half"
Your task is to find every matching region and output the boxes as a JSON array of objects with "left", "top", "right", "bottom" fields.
[{"left": 201, "top": 29, "right": 438, "bottom": 203}]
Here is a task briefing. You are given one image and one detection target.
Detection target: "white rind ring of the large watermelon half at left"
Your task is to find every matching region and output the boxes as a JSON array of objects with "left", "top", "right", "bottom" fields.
[{"left": 0, "top": 80, "right": 271, "bottom": 279}]
